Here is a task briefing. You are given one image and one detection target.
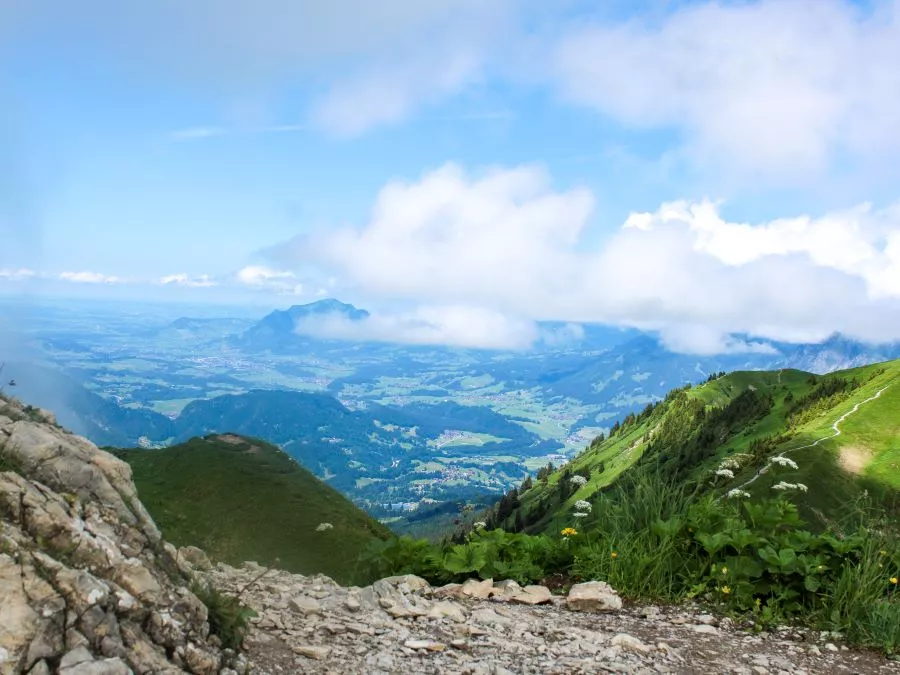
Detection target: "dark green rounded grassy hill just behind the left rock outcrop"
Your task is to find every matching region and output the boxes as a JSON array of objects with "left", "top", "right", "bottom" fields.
[{"left": 116, "top": 436, "right": 389, "bottom": 581}]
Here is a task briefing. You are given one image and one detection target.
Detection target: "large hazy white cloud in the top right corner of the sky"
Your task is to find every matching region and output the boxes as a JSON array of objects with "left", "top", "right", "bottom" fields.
[{"left": 555, "top": 0, "right": 900, "bottom": 180}]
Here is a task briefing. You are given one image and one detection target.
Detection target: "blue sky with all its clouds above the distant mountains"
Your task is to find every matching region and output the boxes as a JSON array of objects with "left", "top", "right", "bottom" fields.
[{"left": 0, "top": 0, "right": 900, "bottom": 353}]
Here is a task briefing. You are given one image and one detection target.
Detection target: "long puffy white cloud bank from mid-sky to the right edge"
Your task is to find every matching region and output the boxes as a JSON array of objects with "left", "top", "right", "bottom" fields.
[{"left": 270, "top": 164, "right": 900, "bottom": 353}]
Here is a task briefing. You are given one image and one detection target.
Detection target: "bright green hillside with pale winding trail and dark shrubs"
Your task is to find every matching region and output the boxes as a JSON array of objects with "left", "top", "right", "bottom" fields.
[{"left": 500, "top": 361, "right": 900, "bottom": 532}]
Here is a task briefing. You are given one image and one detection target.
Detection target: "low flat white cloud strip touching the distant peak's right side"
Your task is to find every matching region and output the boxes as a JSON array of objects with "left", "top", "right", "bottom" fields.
[{"left": 296, "top": 306, "right": 540, "bottom": 349}]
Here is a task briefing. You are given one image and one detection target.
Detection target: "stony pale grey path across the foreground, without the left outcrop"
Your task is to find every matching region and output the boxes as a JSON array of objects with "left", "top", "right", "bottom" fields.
[{"left": 206, "top": 563, "right": 900, "bottom": 675}]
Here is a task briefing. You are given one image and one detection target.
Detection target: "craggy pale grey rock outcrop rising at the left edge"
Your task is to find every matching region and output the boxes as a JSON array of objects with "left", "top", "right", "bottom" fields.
[{"left": 0, "top": 399, "right": 246, "bottom": 675}]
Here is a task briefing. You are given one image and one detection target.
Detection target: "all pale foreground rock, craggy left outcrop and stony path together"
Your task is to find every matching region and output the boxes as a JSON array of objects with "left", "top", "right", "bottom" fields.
[{"left": 0, "top": 399, "right": 900, "bottom": 675}]
